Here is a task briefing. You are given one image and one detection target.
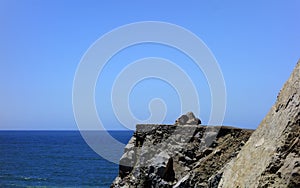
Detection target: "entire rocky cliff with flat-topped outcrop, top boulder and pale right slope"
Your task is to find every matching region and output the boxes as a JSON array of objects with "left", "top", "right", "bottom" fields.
[{"left": 111, "top": 62, "right": 300, "bottom": 188}]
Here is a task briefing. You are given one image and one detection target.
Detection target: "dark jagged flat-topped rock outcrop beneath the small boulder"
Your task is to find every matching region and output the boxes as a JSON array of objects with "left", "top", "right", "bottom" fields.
[{"left": 111, "top": 125, "right": 253, "bottom": 187}]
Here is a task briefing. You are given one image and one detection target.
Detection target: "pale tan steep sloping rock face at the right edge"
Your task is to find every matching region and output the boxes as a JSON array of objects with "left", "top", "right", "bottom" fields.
[{"left": 219, "top": 61, "right": 300, "bottom": 188}]
